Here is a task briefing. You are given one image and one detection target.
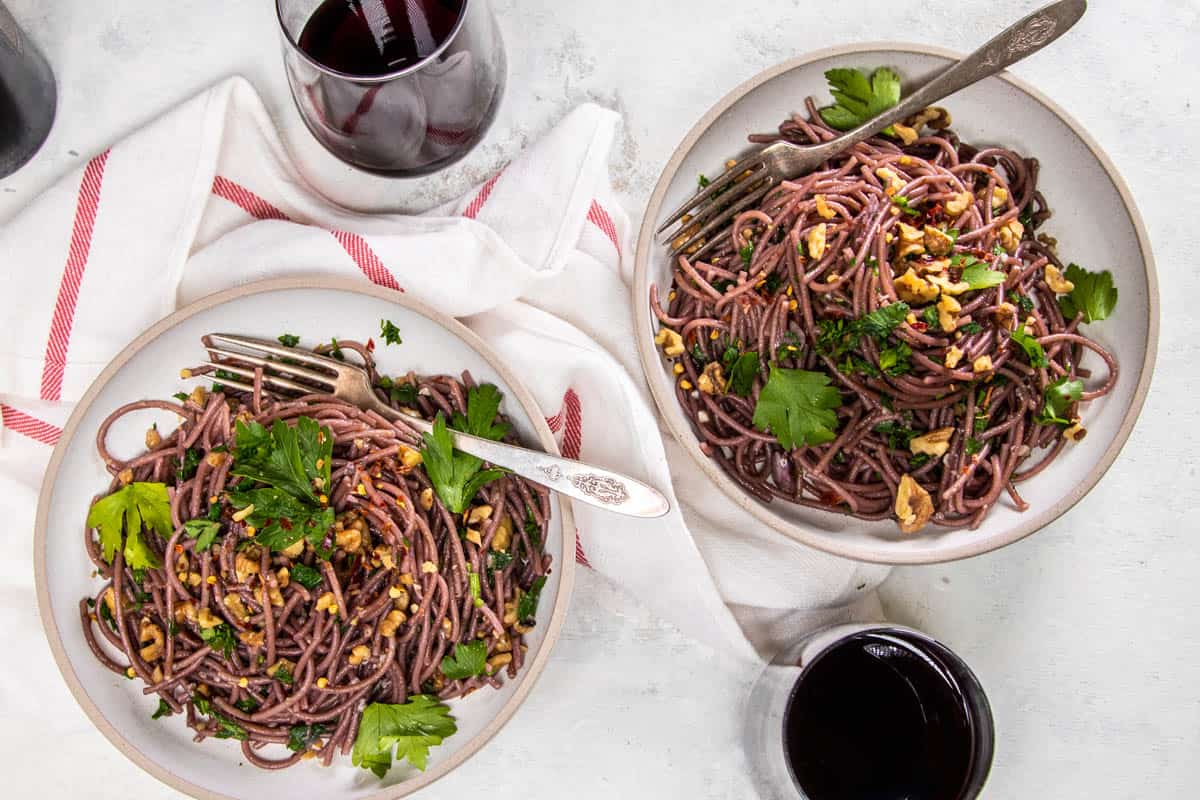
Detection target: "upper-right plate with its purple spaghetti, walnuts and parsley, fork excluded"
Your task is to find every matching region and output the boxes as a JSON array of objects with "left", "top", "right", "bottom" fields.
[{"left": 632, "top": 44, "right": 1158, "bottom": 564}]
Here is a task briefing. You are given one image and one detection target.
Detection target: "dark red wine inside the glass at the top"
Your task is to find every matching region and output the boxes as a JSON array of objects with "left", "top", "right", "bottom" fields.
[{"left": 300, "top": 0, "right": 463, "bottom": 77}]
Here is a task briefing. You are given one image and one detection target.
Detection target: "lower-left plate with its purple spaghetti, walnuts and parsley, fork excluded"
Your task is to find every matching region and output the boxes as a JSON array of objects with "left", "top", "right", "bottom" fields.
[{"left": 35, "top": 279, "right": 574, "bottom": 799}]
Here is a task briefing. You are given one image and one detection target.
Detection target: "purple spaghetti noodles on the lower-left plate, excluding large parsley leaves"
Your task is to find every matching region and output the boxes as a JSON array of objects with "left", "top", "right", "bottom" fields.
[{"left": 79, "top": 342, "right": 551, "bottom": 769}]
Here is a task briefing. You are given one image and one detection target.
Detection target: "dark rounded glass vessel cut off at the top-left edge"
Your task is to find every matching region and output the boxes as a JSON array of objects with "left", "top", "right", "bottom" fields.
[{"left": 0, "top": 4, "right": 58, "bottom": 178}]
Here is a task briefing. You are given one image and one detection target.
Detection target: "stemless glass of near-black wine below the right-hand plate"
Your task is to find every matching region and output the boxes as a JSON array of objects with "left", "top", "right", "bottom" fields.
[{"left": 746, "top": 625, "right": 995, "bottom": 800}]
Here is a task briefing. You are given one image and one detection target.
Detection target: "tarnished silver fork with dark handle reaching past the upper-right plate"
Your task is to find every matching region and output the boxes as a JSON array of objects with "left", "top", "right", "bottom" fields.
[{"left": 655, "top": 0, "right": 1087, "bottom": 258}]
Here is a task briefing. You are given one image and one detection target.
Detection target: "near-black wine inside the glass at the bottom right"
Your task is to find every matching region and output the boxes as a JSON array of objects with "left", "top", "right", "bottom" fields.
[{"left": 784, "top": 632, "right": 976, "bottom": 800}]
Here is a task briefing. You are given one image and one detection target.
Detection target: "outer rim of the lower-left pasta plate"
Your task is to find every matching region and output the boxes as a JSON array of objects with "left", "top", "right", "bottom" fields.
[{"left": 34, "top": 277, "right": 575, "bottom": 800}]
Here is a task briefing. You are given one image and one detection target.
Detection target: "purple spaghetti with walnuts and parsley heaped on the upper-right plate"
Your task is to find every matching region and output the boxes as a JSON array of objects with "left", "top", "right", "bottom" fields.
[{"left": 649, "top": 100, "right": 1117, "bottom": 533}]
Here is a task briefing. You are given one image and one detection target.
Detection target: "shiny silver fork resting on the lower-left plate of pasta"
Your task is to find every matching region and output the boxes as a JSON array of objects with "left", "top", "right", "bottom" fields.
[{"left": 194, "top": 333, "right": 671, "bottom": 517}]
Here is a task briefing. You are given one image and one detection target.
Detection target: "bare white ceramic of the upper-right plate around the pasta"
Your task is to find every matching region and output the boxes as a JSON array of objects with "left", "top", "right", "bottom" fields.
[{"left": 632, "top": 43, "right": 1158, "bottom": 564}]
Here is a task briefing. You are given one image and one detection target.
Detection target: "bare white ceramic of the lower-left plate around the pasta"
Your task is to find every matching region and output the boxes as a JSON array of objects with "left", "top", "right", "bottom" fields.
[{"left": 35, "top": 279, "right": 575, "bottom": 800}]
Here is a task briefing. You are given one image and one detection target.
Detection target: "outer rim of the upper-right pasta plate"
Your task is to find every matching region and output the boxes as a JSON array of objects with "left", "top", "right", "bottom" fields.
[{"left": 631, "top": 41, "right": 1159, "bottom": 565}]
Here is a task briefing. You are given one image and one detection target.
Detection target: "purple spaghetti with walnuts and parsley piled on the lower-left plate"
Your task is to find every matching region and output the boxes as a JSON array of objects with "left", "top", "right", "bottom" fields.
[{"left": 79, "top": 342, "right": 551, "bottom": 775}]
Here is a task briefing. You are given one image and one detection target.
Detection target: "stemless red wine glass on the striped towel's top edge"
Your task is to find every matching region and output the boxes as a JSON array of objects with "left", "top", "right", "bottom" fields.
[{"left": 276, "top": 0, "right": 506, "bottom": 178}]
